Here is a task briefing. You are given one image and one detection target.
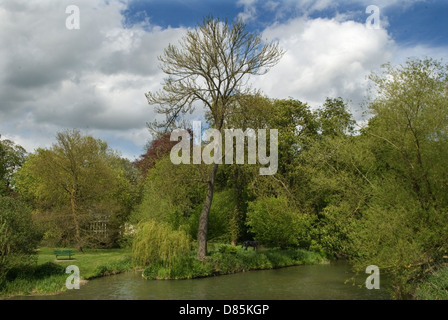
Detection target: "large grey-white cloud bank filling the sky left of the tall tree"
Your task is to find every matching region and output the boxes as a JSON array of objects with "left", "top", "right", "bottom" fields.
[{"left": 0, "top": 0, "right": 184, "bottom": 158}]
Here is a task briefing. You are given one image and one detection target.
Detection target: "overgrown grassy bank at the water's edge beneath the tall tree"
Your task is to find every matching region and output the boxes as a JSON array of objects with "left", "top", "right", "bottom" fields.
[{"left": 143, "top": 246, "right": 328, "bottom": 279}]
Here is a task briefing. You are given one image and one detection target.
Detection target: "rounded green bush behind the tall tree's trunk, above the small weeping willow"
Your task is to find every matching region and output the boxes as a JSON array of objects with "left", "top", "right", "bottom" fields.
[{"left": 131, "top": 156, "right": 235, "bottom": 240}]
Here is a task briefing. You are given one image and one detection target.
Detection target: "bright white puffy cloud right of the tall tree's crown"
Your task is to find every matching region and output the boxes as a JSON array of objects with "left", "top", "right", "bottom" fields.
[{"left": 254, "top": 17, "right": 396, "bottom": 119}]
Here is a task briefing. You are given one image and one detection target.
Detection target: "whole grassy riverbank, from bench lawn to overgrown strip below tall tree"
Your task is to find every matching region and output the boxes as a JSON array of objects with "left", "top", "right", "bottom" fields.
[{"left": 0, "top": 246, "right": 328, "bottom": 299}]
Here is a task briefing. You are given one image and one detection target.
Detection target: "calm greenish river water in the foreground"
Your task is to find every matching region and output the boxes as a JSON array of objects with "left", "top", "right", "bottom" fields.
[{"left": 9, "top": 262, "right": 390, "bottom": 300}]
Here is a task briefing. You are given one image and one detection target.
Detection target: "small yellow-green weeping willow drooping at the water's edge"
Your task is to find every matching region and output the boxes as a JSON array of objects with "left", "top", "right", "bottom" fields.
[{"left": 132, "top": 220, "right": 192, "bottom": 266}]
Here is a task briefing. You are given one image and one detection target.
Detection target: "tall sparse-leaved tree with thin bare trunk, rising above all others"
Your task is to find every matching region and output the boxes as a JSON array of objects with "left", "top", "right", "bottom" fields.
[{"left": 146, "top": 17, "right": 283, "bottom": 260}]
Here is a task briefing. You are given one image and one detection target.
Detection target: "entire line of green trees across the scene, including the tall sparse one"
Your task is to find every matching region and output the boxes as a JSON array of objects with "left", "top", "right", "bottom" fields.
[{"left": 0, "top": 19, "right": 448, "bottom": 298}]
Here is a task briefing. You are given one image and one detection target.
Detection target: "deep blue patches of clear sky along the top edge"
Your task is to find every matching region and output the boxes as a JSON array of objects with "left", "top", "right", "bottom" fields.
[{"left": 123, "top": 0, "right": 448, "bottom": 46}]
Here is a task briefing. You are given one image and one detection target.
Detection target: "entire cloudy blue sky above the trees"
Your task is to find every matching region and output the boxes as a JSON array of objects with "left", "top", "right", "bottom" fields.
[{"left": 0, "top": 0, "right": 448, "bottom": 160}]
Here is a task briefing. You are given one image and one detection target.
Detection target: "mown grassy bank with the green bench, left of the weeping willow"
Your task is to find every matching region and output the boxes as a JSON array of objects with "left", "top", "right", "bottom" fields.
[{"left": 0, "top": 248, "right": 133, "bottom": 298}]
